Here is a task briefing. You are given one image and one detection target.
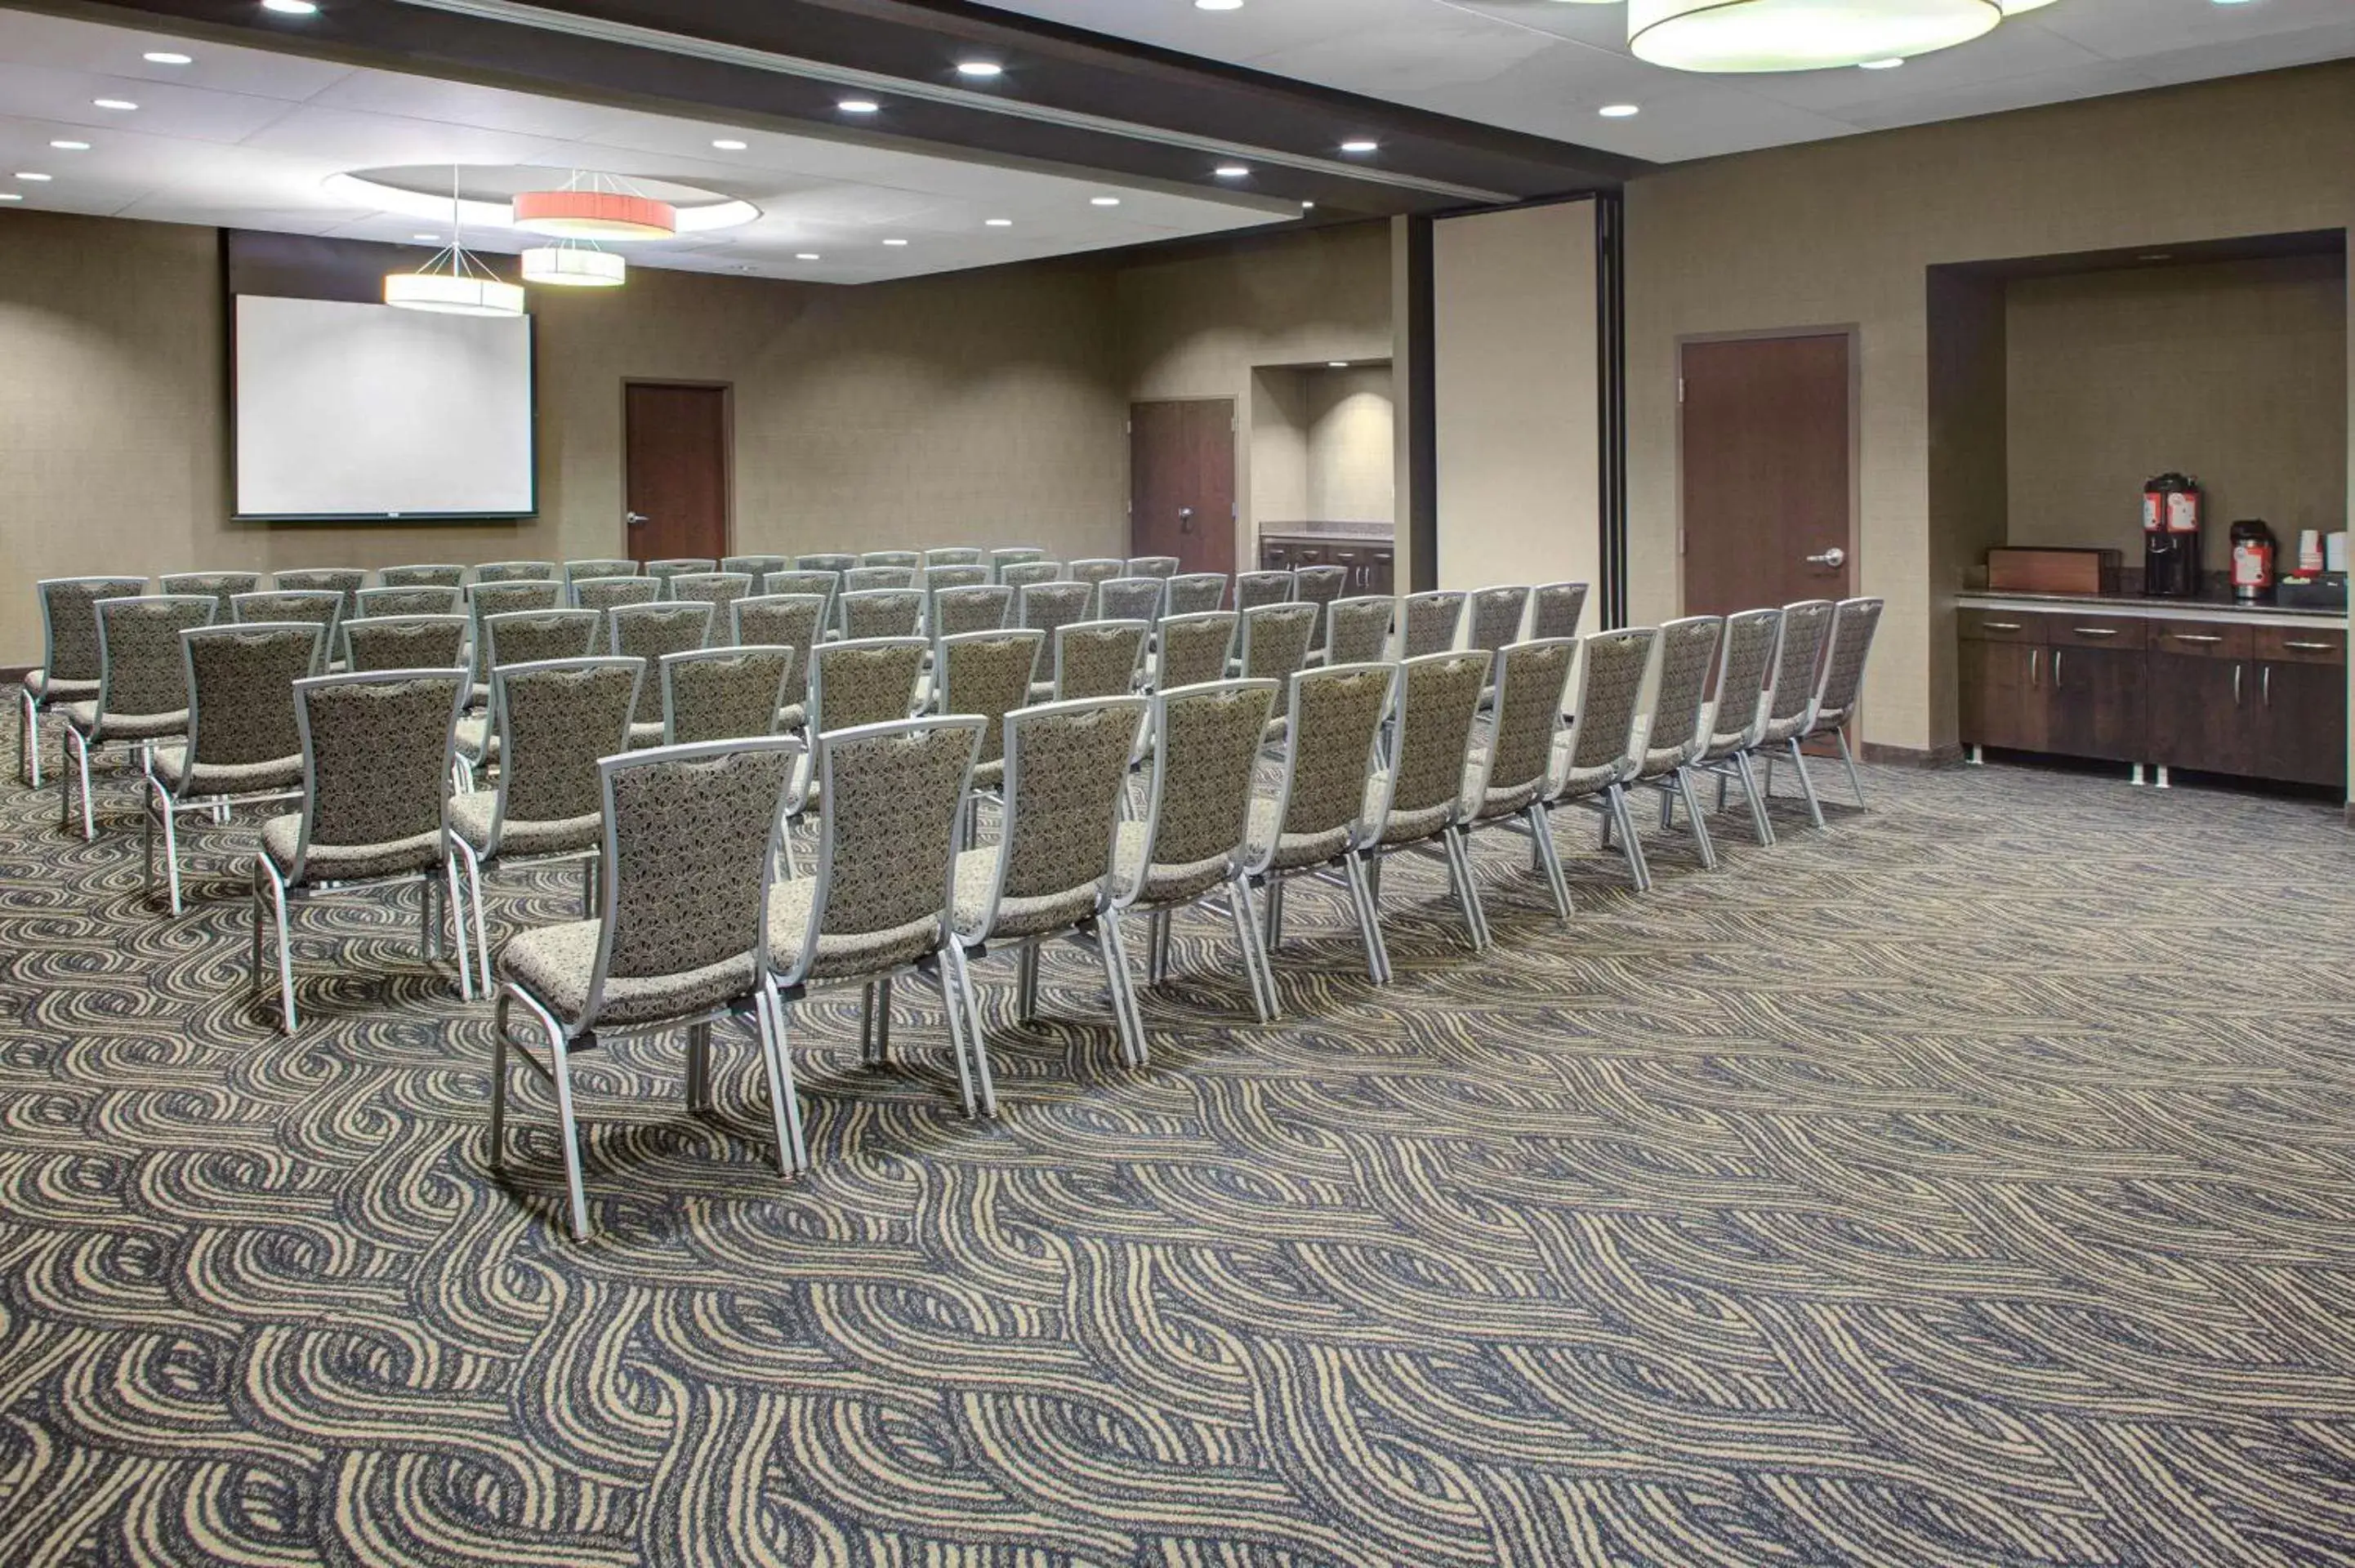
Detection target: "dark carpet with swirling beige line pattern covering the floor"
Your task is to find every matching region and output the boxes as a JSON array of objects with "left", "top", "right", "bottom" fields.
[{"left": 0, "top": 734, "right": 2355, "bottom": 1568}]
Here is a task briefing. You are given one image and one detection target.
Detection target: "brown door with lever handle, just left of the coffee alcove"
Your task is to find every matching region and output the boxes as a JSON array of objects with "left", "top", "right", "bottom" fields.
[{"left": 1679, "top": 334, "right": 1856, "bottom": 614}]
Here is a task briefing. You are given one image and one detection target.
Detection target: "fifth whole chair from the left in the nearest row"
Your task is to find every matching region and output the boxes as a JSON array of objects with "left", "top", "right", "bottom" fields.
[{"left": 1243, "top": 664, "right": 1397, "bottom": 982}]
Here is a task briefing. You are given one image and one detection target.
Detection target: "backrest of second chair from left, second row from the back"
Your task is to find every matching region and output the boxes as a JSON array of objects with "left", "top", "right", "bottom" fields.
[{"left": 490, "top": 657, "right": 645, "bottom": 828}]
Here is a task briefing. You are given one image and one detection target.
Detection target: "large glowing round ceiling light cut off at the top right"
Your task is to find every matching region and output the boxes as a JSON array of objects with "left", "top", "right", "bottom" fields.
[{"left": 1627, "top": 0, "right": 2004, "bottom": 73}]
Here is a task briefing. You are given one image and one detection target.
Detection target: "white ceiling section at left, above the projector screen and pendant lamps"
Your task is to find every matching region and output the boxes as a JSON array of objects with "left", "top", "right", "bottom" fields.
[{"left": 0, "top": 10, "right": 1298, "bottom": 283}]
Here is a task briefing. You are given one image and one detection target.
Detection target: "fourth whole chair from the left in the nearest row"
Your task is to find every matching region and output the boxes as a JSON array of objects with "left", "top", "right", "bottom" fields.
[{"left": 1112, "top": 680, "right": 1277, "bottom": 1026}]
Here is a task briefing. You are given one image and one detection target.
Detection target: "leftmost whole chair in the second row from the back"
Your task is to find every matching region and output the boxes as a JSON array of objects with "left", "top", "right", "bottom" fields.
[{"left": 252, "top": 669, "right": 473, "bottom": 1034}]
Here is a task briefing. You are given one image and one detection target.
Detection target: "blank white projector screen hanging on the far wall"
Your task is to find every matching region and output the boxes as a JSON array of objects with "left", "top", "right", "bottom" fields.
[{"left": 235, "top": 294, "right": 534, "bottom": 520}]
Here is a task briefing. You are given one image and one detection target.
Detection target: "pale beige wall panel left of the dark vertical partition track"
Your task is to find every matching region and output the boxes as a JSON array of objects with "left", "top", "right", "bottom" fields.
[{"left": 1432, "top": 203, "right": 1601, "bottom": 589}]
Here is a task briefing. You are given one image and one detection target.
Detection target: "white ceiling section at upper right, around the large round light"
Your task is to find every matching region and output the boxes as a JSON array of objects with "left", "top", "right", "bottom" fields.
[{"left": 970, "top": 0, "right": 2355, "bottom": 163}]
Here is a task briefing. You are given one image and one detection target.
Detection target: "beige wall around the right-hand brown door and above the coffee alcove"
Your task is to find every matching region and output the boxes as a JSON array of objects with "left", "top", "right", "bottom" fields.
[{"left": 1627, "top": 64, "right": 2355, "bottom": 749}]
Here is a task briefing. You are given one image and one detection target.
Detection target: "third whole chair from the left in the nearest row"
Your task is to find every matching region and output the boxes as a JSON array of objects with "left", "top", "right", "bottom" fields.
[{"left": 949, "top": 694, "right": 1144, "bottom": 1083}]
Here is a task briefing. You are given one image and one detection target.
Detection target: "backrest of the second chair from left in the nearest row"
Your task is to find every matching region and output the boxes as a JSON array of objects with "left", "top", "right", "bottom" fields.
[{"left": 768, "top": 715, "right": 982, "bottom": 984}]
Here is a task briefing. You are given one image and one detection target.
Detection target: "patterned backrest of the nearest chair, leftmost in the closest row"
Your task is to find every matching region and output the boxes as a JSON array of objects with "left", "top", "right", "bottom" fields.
[{"left": 582, "top": 734, "right": 801, "bottom": 1003}]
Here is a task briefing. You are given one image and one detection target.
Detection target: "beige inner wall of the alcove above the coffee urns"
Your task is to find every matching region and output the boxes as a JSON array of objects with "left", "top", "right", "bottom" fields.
[{"left": 2004, "top": 256, "right": 2348, "bottom": 572}]
